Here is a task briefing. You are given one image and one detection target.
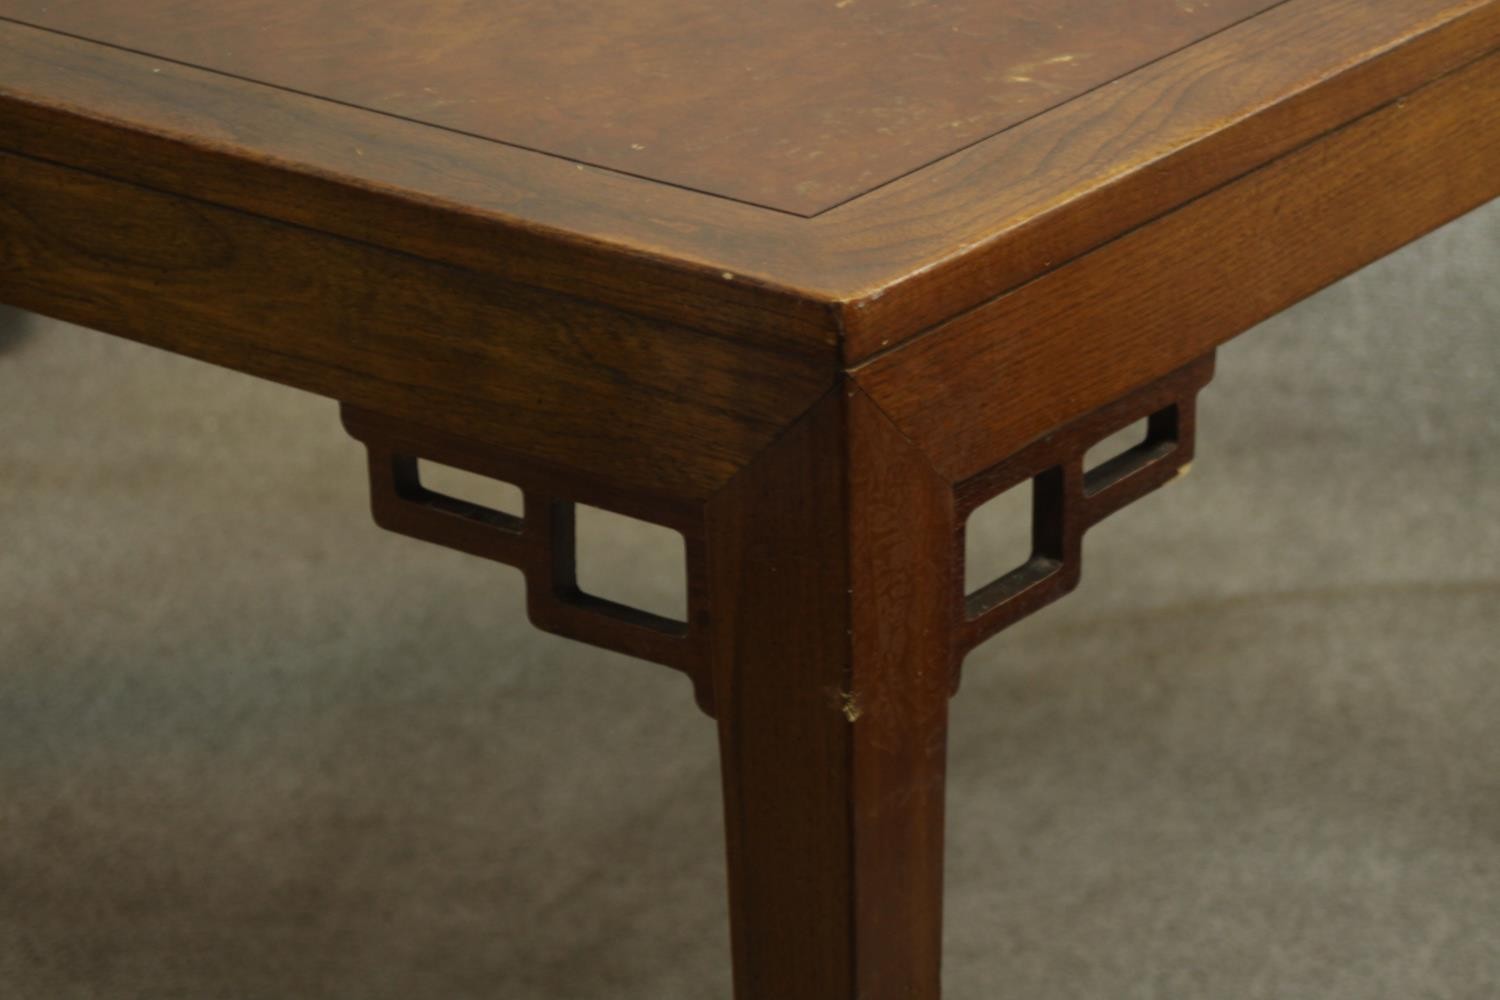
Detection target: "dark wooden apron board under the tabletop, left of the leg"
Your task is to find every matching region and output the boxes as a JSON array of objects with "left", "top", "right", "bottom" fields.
[{"left": 0, "top": 153, "right": 833, "bottom": 498}]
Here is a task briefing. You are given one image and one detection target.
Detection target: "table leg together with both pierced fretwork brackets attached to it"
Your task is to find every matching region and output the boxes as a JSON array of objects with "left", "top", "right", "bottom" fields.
[{"left": 344, "top": 355, "right": 1214, "bottom": 1000}]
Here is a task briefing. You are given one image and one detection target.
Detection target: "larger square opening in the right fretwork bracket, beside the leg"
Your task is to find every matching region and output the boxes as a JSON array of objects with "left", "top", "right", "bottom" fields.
[{"left": 963, "top": 469, "right": 1065, "bottom": 618}]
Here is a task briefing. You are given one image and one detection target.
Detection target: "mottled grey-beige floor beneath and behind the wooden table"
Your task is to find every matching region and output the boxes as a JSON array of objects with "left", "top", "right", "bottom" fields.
[{"left": 0, "top": 205, "right": 1500, "bottom": 1000}]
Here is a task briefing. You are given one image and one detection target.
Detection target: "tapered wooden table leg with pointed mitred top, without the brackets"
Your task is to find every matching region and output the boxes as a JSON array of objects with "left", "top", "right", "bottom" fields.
[{"left": 708, "top": 385, "right": 957, "bottom": 1000}]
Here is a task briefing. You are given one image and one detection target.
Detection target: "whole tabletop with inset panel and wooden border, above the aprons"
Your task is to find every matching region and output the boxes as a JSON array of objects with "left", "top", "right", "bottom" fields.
[{"left": 0, "top": 0, "right": 1500, "bottom": 363}]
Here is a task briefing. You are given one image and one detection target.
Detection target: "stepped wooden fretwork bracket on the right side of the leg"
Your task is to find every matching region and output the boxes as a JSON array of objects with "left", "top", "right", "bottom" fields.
[{"left": 954, "top": 354, "right": 1214, "bottom": 687}]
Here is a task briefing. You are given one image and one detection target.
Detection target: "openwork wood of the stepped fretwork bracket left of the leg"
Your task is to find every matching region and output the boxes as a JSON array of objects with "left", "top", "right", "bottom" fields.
[{"left": 344, "top": 406, "right": 714, "bottom": 715}]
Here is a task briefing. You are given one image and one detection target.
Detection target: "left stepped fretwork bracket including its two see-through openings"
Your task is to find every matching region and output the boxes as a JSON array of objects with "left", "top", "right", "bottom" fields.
[{"left": 344, "top": 405, "right": 714, "bottom": 715}]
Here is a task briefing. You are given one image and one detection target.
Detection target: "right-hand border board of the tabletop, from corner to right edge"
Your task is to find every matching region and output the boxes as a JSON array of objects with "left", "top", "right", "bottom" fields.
[{"left": 816, "top": 0, "right": 1500, "bottom": 363}]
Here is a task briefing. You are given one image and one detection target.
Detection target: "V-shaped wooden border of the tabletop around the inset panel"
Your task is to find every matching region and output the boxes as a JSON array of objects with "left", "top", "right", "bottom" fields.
[{"left": 0, "top": 0, "right": 1500, "bottom": 361}]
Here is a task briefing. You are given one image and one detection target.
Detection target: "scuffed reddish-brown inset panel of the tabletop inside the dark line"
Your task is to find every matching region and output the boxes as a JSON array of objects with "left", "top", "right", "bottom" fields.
[{"left": 0, "top": 0, "right": 1277, "bottom": 214}]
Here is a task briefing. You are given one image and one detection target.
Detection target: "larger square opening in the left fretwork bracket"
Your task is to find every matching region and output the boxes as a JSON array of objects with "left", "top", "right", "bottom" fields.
[{"left": 575, "top": 504, "right": 687, "bottom": 624}]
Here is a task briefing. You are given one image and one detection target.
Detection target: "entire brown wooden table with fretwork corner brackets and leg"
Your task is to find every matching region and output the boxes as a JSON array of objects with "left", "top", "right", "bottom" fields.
[{"left": 0, "top": 0, "right": 1500, "bottom": 1000}]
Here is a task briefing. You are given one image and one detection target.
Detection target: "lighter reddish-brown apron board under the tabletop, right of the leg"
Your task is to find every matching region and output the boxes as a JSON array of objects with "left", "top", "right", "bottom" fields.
[{"left": 857, "top": 46, "right": 1500, "bottom": 481}]
